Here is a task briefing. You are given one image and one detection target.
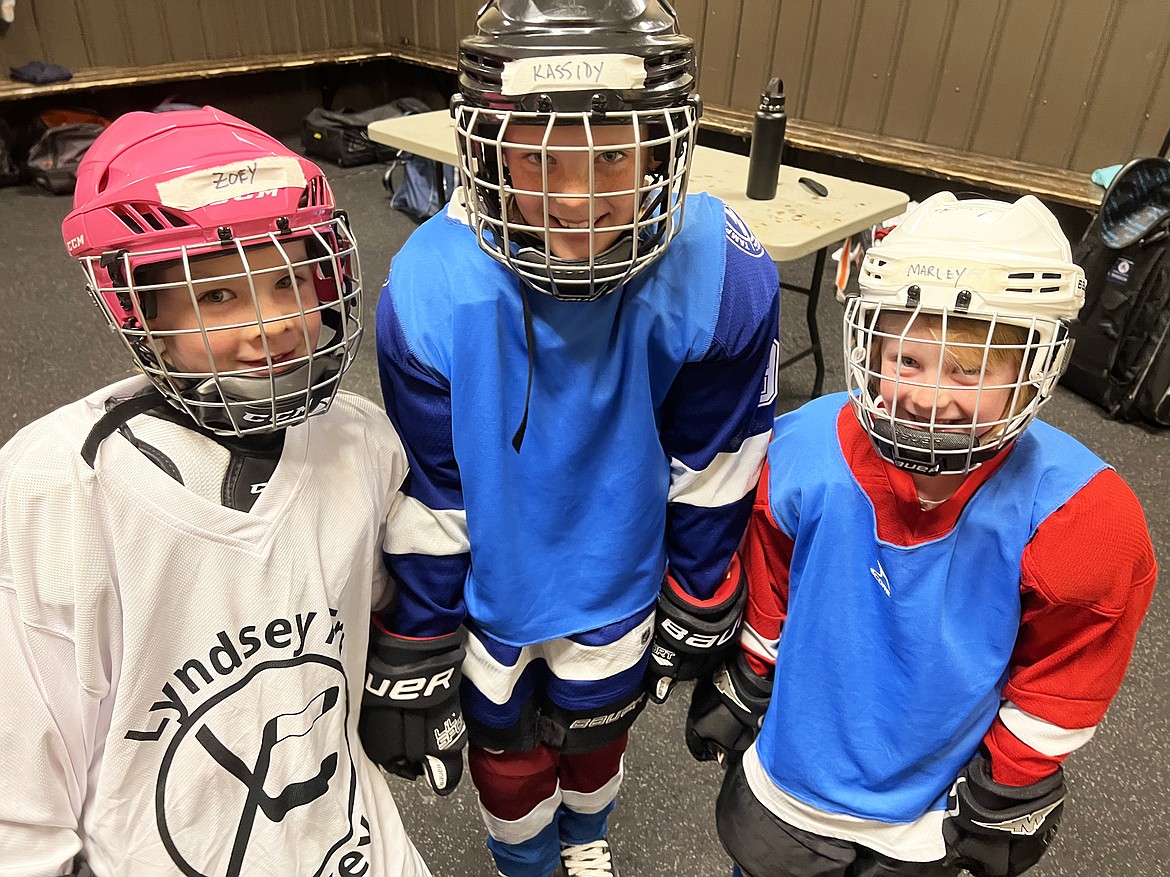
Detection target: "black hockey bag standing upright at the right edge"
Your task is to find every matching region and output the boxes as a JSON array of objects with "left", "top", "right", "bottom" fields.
[{"left": 1062, "top": 158, "right": 1170, "bottom": 426}]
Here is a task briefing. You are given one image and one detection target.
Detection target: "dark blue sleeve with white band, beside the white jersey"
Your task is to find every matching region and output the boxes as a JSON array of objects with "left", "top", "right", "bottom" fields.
[{"left": 377, "top": 278, "right": 470, "bottom": 637}]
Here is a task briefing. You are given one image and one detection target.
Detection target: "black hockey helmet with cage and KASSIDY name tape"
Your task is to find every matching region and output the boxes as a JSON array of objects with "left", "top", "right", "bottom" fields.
[{"left": 452, "top": 0, "right": 702, "bottom": 301}]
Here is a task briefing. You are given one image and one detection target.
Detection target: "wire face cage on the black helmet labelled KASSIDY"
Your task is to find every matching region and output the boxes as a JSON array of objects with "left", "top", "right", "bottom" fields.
[{"left": 454, "top": 97, "right": 700, "bottom": 301}]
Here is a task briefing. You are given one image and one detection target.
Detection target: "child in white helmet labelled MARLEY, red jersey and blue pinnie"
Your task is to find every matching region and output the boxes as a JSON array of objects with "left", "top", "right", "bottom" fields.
[{"left": 687, "top": 193, "right": 1157, "bottom": 877}]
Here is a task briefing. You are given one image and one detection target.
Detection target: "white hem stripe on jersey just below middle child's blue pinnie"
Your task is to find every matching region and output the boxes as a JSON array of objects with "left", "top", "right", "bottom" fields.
[{"left": 463, "top": 613, "right": 654, "bottom": 704}]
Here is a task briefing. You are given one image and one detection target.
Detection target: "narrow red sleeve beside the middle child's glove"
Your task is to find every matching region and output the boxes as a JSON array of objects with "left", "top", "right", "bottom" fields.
[{"left": 739, "top": 464, "right": 792, "bottom": 676}]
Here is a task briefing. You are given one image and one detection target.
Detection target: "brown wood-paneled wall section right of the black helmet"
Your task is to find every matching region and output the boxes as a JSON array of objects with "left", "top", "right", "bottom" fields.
[{"left": 676, "top": 0, "right": 1170, "bottom": 171}]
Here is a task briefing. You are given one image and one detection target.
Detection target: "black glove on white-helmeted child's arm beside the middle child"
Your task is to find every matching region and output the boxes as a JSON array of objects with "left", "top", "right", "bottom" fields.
[{"left": 687, "top": 651, "right": 772, "bottom": 765}]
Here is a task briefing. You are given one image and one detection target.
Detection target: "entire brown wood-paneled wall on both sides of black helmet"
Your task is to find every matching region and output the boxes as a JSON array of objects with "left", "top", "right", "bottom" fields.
[{"left": 0, "top": 0, "right": 1170, "bottom": 171}]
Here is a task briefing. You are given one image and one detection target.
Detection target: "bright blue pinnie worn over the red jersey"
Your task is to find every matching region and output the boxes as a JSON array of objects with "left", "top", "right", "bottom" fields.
[{"left": 756, "top": 394, "right": 1106, "bottom": 823}]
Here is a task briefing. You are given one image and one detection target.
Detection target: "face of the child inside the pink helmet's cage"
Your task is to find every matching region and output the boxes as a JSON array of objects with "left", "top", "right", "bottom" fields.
[{"left": 149, "top": 241, "right": 321, "bottom": 377}]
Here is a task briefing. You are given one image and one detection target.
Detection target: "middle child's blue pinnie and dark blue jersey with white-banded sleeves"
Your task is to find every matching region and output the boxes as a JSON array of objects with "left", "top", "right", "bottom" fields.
[{"left": 378, "top": 195, "right": 779, "bottom": 645}]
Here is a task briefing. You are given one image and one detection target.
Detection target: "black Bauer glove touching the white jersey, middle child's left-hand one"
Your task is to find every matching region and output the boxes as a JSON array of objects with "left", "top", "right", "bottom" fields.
[{"left": 358, "top": 628, "right": 467, "bottom": 795}]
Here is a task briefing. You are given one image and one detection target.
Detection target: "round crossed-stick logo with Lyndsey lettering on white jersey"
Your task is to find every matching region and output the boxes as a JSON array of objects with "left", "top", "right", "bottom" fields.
[{"left": 146, "top": 645, "right": 371, "bottom": 877}]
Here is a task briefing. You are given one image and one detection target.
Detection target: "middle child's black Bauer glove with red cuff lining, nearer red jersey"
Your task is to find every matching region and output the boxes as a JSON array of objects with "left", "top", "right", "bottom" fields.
[{"left": 646, "top": 557, "right": 748, "bottom": 704}]
